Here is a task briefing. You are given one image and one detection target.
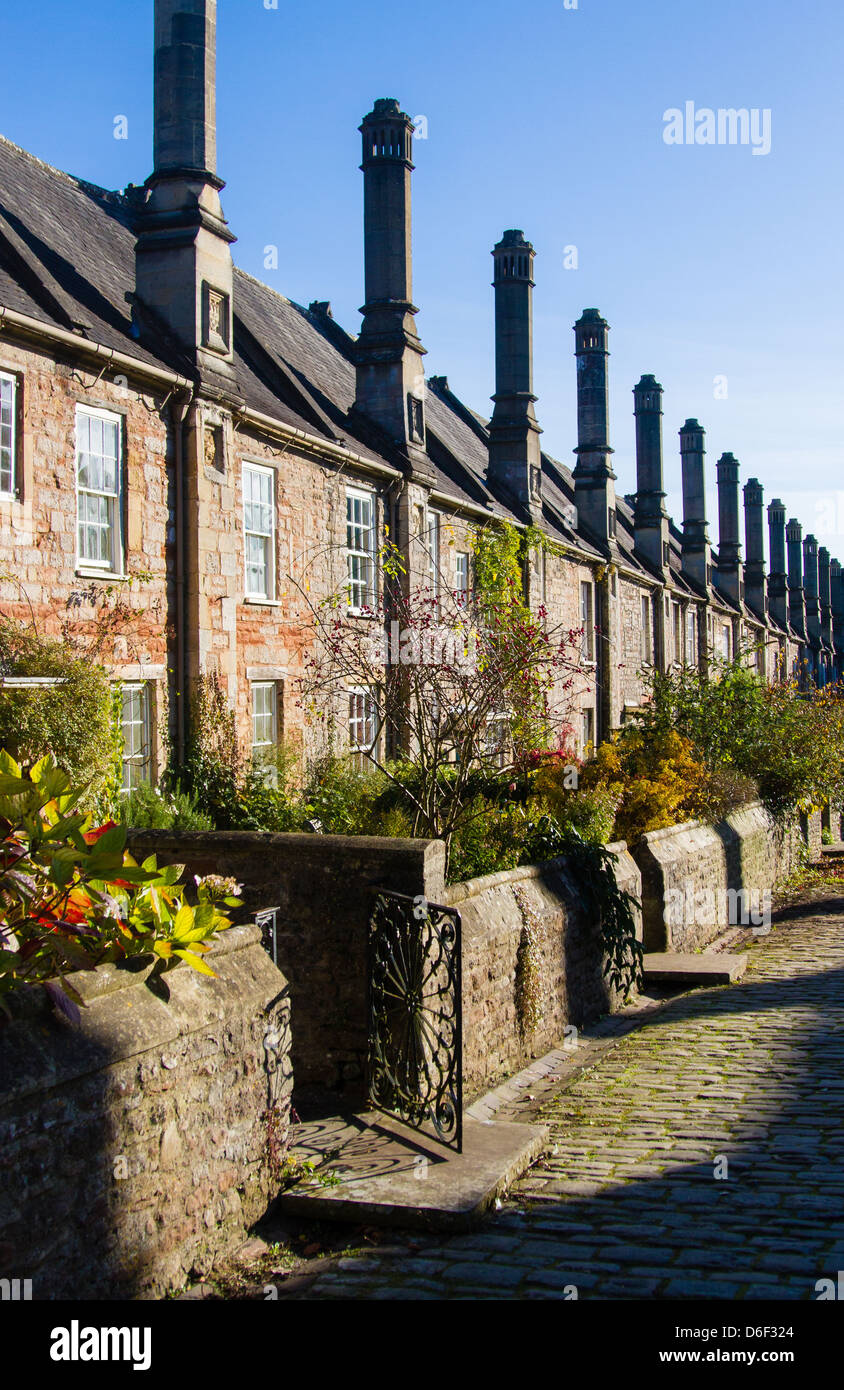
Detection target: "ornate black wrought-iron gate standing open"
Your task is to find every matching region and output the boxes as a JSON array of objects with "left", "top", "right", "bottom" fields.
[{"left": 368, "top": 891, "right": 463, "bottom": 1154}]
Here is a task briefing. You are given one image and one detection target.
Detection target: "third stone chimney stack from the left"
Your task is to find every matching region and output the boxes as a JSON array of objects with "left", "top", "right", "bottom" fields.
[{"left": 489, "top": 231, "right": 542, "bottom": 523}]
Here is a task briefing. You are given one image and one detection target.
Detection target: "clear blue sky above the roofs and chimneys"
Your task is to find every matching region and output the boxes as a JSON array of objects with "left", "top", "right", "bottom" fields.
[{"left": 0, "top": 0, "right": 844, "bottom": 560}]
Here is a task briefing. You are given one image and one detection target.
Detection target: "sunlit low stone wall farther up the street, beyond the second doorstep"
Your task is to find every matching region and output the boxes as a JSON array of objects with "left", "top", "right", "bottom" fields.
[{"left": 631, "top": 802, "right": 820, "bottom": 951}]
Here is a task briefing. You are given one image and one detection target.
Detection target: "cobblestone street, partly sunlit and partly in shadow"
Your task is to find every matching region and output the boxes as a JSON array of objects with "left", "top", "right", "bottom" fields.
[{"left": 298, "top": 898, "right": 844, "bottom": 1300}]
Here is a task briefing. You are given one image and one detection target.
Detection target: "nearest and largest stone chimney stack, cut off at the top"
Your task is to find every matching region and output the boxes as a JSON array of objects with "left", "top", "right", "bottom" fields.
[{"left": 135, "top": 0, "right": 235, "bottom": 389}]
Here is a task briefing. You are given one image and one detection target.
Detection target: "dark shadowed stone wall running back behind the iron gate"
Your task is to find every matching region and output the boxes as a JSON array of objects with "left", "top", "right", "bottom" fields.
[{"left": 129, "top": 830, "right": 445, "bottom": 1099}]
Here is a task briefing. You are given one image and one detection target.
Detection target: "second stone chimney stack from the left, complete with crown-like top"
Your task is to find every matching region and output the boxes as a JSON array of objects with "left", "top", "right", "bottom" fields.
[{"left": 355, "top": 97, "right": 430, "bottom": 478}]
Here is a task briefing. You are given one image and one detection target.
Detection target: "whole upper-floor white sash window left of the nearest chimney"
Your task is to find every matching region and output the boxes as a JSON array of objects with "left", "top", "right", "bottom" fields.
[{"left": 76, "top": 406, "right": 122, "bottom": 573}]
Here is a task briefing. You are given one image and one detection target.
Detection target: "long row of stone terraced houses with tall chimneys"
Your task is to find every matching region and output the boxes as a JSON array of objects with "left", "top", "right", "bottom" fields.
[{"left": 0, "top": 0, "right": 844, "bottom": 785}]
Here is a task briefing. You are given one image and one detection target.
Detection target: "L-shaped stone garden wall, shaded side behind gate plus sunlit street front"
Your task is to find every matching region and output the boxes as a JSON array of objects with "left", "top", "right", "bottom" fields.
[{"left": 129, "top": 830, "right": 640, "bottom": 1105}]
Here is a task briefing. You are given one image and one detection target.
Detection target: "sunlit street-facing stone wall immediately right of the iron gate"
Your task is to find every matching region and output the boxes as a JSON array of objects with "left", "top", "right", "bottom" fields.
[{"left": 445, "top": 844, "right": 641, "bottom": 1099}]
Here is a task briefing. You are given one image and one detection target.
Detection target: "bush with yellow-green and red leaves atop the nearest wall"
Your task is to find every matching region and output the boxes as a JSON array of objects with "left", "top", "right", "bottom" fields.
[{"left": 0, "top": 752, "right": 239, "bottom": 1017}]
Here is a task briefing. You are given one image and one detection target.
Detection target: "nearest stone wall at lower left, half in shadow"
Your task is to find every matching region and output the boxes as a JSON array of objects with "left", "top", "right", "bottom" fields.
[{"left": 0, "top": 926, "right": 292, "bottom": 1300}]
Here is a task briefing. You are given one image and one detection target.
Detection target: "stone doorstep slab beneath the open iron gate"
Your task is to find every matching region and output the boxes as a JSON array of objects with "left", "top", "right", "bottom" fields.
[{"left": 278, "top": 1111, "right": 548, "bottom": 1230}]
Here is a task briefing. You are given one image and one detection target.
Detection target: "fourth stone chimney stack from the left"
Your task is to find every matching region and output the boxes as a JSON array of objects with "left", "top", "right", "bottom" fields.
[{"left": 573, "top": 309, "right": 616, "bottom": 546}]
